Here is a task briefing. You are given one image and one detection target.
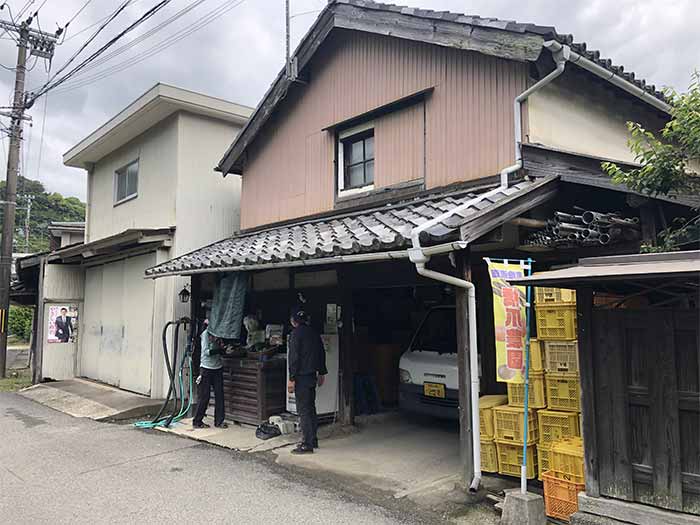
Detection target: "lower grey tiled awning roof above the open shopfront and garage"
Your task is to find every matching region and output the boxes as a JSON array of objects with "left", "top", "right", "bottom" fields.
[{"left": 146, "top": 181, "right": 541, "bottom": 277}]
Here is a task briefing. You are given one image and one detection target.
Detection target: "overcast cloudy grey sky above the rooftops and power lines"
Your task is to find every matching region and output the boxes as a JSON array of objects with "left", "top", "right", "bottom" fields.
[{"left": 0, "top": 0, "right": 700, "bottom": 199}]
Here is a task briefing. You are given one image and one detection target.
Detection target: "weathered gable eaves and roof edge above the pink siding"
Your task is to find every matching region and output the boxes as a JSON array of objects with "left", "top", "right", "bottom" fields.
[{"left": 216, "top": 0, "right": 666, "bottom": 176}]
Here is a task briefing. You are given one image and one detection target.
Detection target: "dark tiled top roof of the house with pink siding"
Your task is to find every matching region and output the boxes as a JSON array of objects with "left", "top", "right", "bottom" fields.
[{"left": 342, "top": 0, "right": 668, "bottom": 102}]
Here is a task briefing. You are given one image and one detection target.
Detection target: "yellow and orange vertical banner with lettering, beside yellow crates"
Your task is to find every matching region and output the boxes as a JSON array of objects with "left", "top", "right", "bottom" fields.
[{"left": 484, "top": 258, "right": 528, "bottom": 383}]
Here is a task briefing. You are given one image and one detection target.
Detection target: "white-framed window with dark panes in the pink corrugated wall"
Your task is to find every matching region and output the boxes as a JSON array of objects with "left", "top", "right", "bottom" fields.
[{"left": 338, "top": 122, "right": 374, "bottom": 195}]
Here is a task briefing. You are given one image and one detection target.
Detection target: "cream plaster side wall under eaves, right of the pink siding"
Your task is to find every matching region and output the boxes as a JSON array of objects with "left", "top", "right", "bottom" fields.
[{"left": 526, "top": 70, "right": 663, "bottom": 162}]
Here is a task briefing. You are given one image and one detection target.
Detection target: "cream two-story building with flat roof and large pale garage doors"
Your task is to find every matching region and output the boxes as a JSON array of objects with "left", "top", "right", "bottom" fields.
[{"left": 14, "top": 84, "right": 252, "bottom": 398}]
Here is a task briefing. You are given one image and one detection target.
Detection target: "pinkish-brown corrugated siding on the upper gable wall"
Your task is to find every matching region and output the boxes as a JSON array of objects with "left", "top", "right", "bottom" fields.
[{"left": 241, "top": 30, "right": 528, "bottom": 228}]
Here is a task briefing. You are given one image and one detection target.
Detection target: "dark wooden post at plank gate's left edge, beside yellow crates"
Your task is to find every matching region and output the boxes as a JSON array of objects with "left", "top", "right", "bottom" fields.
[{"left": 576, "top": 288, "right": 600, "bottom": 496}]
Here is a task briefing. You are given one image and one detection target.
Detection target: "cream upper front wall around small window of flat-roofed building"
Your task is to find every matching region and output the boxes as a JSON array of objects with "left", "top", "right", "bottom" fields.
[{"left": 86, "top": 116, "right": 178, "bottom": 242}]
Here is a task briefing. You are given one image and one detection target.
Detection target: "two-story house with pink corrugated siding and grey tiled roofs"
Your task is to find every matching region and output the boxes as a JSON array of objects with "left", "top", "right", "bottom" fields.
[{"left": 147, "top": 0, "right": 700, "bottom": 520}]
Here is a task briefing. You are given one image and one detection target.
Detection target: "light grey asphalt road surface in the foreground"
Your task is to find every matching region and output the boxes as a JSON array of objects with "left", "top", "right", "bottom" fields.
[{"left": 0, "top": 394, "right": 426, "bottom": 525}]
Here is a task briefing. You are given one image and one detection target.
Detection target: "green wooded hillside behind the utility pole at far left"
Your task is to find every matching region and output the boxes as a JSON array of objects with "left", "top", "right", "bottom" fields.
[{"left": 0, "top": 176, "right": 85, "bottom": 252}]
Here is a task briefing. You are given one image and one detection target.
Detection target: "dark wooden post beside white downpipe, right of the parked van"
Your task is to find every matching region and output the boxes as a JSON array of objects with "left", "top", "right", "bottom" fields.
[{"left": 455, "top": 249, "right": 474, "bottom": 486}]
